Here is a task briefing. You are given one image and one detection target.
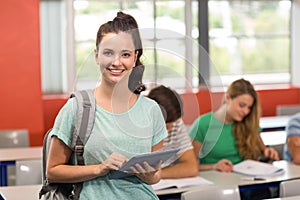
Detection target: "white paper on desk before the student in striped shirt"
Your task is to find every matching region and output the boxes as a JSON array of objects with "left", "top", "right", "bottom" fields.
[{"left": 152, "top": 176, "right": 214, "bottom": 190}]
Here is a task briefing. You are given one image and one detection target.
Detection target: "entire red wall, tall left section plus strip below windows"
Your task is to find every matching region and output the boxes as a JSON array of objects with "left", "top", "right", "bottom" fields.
[{"left": 0, "top": 0, "right": 300, "bottom": 146}]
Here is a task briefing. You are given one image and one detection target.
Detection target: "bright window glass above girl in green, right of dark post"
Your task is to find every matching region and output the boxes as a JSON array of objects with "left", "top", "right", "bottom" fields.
[{"left": 209, "top": 1, "right": 291, "bottom": 84}]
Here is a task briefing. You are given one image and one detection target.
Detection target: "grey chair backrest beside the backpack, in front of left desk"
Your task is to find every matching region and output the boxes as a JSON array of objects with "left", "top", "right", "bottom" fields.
[{"left": 16, "top": 159, "right": 42, "bottom": 185}]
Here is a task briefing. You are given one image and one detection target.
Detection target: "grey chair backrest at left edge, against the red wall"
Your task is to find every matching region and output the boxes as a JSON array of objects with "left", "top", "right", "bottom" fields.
[{"left": 0, "top": 129, "right": 29, "bottom": 148}]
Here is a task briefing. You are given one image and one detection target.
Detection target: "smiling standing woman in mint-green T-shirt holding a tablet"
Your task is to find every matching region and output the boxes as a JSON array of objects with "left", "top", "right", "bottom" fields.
[{"left": 46, "top": 12, "right": 167, "bottom": 200}]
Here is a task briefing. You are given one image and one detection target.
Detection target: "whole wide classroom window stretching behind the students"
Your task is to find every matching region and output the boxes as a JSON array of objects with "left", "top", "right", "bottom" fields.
[{"left": 41, "top": 0, "right": 293, "bottom": 93}]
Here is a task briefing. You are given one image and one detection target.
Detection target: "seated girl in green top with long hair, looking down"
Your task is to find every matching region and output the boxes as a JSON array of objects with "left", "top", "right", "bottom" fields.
[{"left": 189, "top": 79, "right": 279, "bottom": 172}]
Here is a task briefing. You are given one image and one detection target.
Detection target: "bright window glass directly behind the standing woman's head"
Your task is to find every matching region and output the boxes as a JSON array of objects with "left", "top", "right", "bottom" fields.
[{"left": 74, "top": 0, "right": 190, "bottom": 89}]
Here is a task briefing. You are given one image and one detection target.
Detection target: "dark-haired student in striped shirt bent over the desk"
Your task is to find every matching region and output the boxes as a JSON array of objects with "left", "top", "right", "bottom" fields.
[{"left": 148, "top": 86, "right": 198, "bottom": 179}]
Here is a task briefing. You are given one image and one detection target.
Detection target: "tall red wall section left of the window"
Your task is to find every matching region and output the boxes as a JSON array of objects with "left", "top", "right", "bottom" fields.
[{"left": 0, "top": 0, "right": 44, "bottom": 145}]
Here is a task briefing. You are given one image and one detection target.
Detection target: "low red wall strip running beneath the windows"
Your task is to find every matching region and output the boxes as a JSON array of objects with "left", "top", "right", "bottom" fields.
[{"left": 44, "top": 85, "right": 300, "bottom": 136}]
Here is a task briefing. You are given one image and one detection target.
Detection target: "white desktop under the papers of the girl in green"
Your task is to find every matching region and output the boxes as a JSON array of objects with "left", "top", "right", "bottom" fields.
[{"left": 156, "top": 160, "right": 300, "bottom": 196}]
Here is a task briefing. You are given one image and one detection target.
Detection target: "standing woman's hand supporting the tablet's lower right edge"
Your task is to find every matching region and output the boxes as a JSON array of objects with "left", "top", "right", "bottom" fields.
[{"left": 130, "top": 161, "right": 161, "bottom": 184}]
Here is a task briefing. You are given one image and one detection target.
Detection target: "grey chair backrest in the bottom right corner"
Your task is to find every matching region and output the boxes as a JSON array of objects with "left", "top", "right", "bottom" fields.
[{"left": 279, "top": 179, "right": 300, "bottom": 197}]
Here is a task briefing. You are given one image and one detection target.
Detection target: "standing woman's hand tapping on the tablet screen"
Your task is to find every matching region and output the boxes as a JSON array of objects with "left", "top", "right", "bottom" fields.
[{"left": 102, "top": 153, "right": 128, "bottom": 175}]
